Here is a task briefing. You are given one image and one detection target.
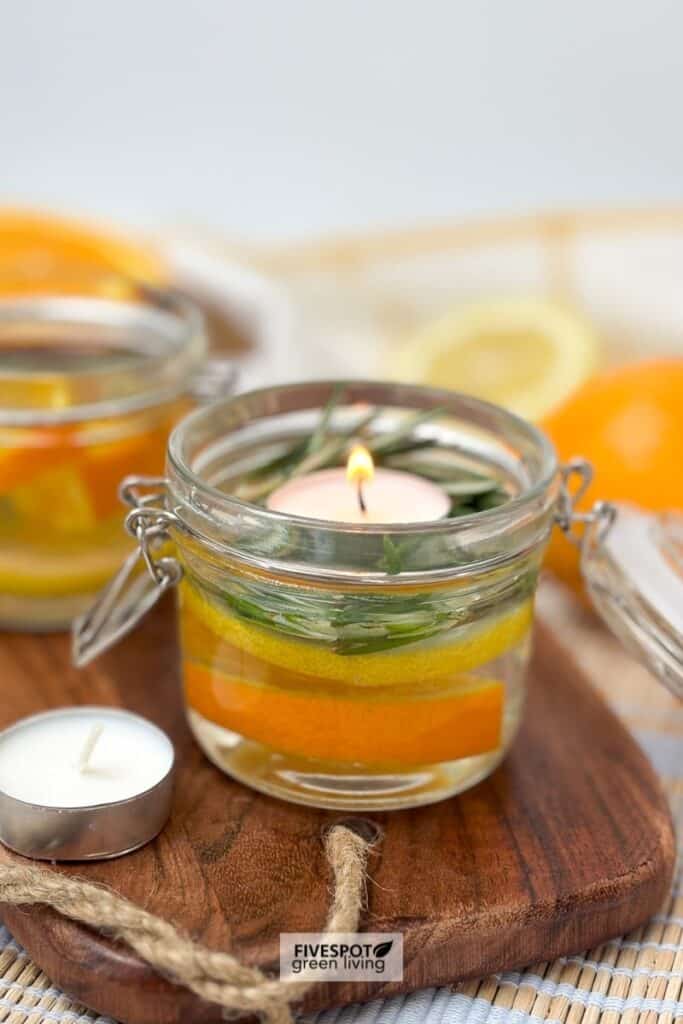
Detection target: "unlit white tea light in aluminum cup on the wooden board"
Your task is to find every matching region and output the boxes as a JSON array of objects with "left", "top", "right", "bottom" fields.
[{"left": 0, "top": 707, "right": 174, "bottom": 860}]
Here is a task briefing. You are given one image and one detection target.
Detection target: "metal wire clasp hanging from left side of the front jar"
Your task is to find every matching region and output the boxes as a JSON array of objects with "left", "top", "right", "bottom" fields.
[{"left": 72, "top": 476, "right": 182, "bottom": 668}]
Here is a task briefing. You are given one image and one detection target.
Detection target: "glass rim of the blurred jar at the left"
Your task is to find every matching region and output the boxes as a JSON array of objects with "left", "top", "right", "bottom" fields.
[{"left": 0, "top": 285, "right": 208, "bottom": 427}]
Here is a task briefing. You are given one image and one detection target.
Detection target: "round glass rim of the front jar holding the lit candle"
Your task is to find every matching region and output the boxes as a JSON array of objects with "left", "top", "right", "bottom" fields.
[{"left": 167, "top": 379, "right": 558, "bottom": 537}]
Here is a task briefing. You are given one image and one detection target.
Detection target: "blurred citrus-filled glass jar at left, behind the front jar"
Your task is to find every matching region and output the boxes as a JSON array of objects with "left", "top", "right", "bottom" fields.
[{"left": 0, "top": 291, "right": 232, "bottom": 630}]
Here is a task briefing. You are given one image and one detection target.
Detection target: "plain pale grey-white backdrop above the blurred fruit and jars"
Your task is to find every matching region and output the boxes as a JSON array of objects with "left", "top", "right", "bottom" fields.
[{"left": 0, "top": 0, "right": 683, "bottom": 239}]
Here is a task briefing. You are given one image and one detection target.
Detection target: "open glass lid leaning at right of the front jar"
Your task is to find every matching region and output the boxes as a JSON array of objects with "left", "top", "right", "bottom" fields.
[{"left": 581, "top": 503, "right": 683, "bottom": 697}]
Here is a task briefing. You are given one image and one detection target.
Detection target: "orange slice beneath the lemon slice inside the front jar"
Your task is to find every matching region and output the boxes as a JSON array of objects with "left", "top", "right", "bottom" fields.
[{"left": 184, "top": 663, "right": 505, "bottom": 765}]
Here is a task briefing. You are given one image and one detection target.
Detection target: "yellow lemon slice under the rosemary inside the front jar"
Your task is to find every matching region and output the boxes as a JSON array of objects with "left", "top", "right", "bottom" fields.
[{"left": 180, "top": 579, "right": 533, "bottom": 686}]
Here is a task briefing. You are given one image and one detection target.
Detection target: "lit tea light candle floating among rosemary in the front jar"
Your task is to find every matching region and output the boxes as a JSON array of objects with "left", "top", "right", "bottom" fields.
[{"left": 267, "top": 444, "right": 451, "bottom": 524}]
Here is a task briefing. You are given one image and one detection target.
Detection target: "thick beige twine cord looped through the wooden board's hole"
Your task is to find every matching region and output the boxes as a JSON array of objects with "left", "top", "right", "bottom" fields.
[{"left": 0, "top": 825, "right": 371, "bottom": 1024}]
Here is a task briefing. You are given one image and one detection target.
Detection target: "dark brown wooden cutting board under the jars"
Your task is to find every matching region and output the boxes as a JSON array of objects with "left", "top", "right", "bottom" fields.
[{"left": 0, "top": 603, "right": 674, "bottom": 1024}]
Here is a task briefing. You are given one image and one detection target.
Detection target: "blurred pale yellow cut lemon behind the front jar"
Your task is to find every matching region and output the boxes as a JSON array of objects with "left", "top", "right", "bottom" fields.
[{"left": 395, "top": 299, "right": 600, "bottom": 420}]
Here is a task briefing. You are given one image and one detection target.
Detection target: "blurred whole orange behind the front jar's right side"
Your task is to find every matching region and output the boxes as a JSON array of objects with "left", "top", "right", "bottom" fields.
[{"left": 542, "top": 358, "right": 683, "bottom": 592}]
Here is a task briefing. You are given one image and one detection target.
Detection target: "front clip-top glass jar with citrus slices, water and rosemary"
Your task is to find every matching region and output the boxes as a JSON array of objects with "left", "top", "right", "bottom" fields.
[{"left": 74, "top": 382, "right": 683, "bottom": 810}]
